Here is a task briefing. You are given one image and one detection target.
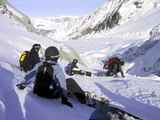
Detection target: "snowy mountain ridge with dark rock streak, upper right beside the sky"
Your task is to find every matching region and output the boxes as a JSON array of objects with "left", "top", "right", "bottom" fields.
[{"left": 70, "top": 0, "right": 160, "bottom": 38}]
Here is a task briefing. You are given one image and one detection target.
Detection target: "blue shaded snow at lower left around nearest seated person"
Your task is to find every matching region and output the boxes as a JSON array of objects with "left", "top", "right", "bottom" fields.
[{"left": 0, "top": 63, "right": 93, "bottom": 120}]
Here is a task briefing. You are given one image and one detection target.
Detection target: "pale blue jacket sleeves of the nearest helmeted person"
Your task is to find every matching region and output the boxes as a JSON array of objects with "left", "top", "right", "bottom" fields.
[{"left": 23, "top": 61, "right": 66, "bottom": 89}]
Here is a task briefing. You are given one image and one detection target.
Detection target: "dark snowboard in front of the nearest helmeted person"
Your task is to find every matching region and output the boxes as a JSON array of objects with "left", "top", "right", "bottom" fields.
[{"left": 66, "top": 78, "right": 142, "bottom": 120}]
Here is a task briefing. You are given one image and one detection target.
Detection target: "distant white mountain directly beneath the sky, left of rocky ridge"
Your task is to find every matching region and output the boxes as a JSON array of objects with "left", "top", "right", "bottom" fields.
[{"left": 31, "top": 16, "right": 82, "bottom": 41}]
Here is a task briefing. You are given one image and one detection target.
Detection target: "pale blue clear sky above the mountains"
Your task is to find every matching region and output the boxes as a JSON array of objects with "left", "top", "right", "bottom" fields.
[{"left": 8, "top": 0, "right": 106, "bottom": 16}]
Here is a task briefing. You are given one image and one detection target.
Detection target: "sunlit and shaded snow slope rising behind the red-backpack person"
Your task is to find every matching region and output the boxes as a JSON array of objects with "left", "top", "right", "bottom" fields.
[{"left": 63, "top": 2, "right": 160, "bottom": 75}]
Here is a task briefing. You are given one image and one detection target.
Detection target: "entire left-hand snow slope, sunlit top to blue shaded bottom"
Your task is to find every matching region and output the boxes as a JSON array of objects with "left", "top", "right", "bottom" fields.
[{"left": 0, "top": 12, "right": 93, "bottom": 120}]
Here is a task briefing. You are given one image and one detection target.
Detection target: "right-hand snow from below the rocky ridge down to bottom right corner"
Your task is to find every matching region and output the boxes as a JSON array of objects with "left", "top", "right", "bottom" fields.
[{"left": 62, "top": 1, "right": 160, "bottom": 120}]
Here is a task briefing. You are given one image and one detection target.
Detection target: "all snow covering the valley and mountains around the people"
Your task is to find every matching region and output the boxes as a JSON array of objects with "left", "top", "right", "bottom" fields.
[{"left": 0, "top": 0, "right": 160, "bottom": 120}]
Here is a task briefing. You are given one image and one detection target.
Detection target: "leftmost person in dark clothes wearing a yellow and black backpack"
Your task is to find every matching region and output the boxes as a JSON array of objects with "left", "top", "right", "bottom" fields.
[{"left": 19, "top": 44, "right": 41, "bottom": 72}]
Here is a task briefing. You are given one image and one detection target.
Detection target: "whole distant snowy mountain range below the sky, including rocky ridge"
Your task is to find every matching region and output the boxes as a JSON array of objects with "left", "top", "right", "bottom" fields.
[{"left": 32, "top": 0, "right": 160, "bottom": 40}]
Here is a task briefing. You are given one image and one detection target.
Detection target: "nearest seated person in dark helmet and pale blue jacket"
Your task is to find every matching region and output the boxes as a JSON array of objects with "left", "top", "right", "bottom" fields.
[{"left": 17, "top": 46, "right": 73, "bottom": 107}]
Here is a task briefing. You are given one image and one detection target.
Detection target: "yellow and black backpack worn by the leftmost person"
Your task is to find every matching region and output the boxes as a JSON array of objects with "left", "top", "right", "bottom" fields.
[{"left": 19, "top": 51, "right": 30, "bottom": 72}]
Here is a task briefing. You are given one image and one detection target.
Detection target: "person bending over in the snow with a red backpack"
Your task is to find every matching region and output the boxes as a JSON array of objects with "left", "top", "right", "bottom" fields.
[{"left": 103, "top": 57, "right": 125, "bottom": 77}]
